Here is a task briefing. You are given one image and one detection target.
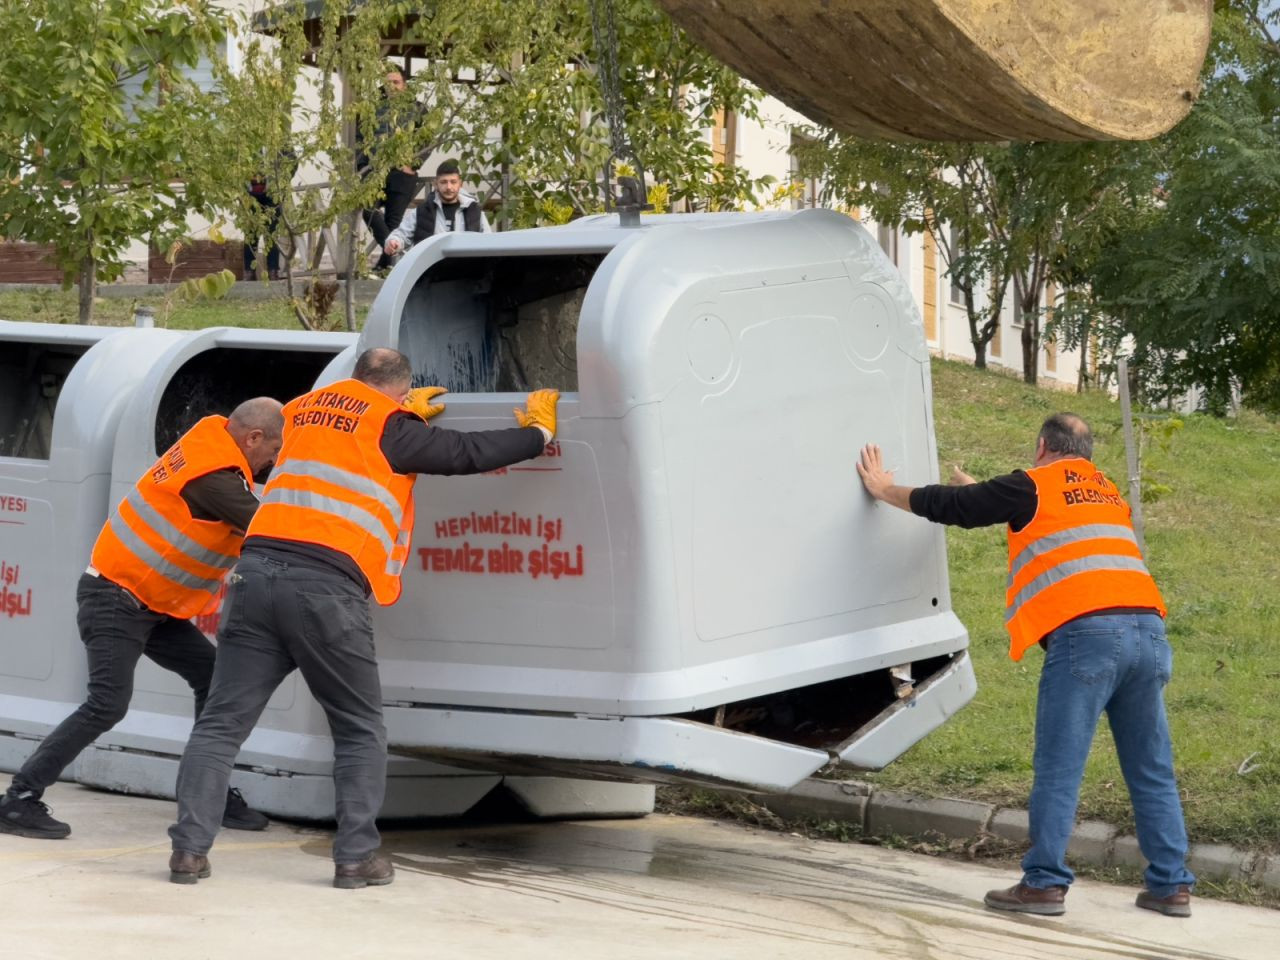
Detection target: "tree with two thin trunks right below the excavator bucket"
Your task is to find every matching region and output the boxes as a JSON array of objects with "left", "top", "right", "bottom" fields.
[{"left": 796, "top": 132, "right": 1151, "bottom": 383}]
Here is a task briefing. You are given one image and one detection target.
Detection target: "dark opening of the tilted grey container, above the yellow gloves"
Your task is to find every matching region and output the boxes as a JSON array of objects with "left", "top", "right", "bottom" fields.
[{"left": 399, "top": 253, "right": 604, "bottom": 393}]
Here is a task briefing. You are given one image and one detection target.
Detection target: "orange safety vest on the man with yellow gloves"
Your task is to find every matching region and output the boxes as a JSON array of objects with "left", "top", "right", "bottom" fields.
[{"left": 248, "top": 380, "right": 417, "bottom": 605}]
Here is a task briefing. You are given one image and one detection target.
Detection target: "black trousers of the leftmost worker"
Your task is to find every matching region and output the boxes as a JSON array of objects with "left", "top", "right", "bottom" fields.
[{"left": 9, "top": 573, "right": 215, "bottom": 803}]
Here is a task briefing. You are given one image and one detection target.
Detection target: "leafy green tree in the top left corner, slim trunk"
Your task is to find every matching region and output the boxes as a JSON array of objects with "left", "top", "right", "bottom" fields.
[{"left": 0, "top": 0, "right": 224, "bottom": 323}]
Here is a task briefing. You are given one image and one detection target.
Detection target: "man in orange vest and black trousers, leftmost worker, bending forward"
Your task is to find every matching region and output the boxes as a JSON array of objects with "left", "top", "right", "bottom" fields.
[{"left": 0, "top": 397, "right": 284, "bottom": 840}]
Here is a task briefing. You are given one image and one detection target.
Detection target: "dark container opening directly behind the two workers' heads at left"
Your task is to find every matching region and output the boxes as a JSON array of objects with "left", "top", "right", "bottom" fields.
[{"left": 155, "top": 347, "right": 334, "bottom": 452}]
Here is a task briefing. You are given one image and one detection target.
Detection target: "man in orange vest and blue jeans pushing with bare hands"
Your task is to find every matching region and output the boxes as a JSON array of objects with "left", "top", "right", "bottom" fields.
[{"left": 858, "top": 413, "right": 1196, "bottom": 916}]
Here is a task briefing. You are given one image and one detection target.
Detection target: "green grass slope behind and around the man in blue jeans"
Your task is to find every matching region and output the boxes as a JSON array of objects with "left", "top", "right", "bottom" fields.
[{"left": 860, "top": 361, "right": 1280, "bottom": 850}]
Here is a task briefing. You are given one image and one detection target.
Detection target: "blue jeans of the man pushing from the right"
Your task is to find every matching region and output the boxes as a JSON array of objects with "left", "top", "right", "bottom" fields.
[{"left": 1023, "top": 613, "right": 1196, "bottom": 897}]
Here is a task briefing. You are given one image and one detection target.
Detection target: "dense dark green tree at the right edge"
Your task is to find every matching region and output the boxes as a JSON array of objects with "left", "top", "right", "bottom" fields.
[{"left": 1074, "top": 0, "right": 1280, "bottom": 412}]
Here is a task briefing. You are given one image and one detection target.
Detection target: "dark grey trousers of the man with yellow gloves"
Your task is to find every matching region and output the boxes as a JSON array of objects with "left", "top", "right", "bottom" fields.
[{"left": 169, "top": 552, "right": 387, "bottom": 864}]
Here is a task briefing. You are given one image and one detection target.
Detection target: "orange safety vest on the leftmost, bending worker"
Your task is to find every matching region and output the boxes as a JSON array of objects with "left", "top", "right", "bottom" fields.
[{"left": 90, "top": 416, "right": 253, "bottom": 620}]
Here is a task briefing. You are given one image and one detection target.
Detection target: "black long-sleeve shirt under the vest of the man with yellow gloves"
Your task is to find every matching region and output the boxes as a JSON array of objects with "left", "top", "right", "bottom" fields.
[{"left": 244, "top": 413, "right": 547, "bottom": 594}]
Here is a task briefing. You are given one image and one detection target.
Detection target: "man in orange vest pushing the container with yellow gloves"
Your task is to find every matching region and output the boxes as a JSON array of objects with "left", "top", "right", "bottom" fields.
[{"left": 169, "top": 349, "right": 559, "bottom": 888}]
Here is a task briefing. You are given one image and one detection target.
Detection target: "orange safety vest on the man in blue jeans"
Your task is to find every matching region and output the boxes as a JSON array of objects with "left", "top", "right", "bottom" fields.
[{"left": 1005, "top": 458, "right": 1166, "bottom": 660}]
